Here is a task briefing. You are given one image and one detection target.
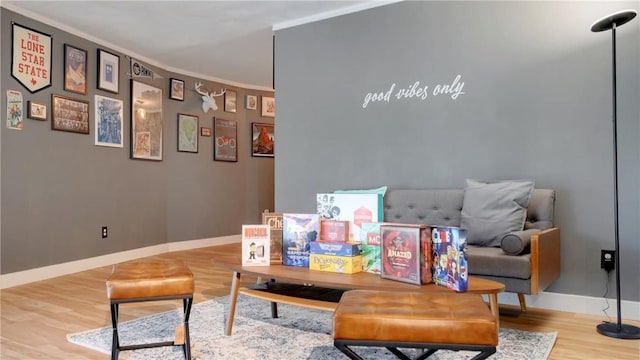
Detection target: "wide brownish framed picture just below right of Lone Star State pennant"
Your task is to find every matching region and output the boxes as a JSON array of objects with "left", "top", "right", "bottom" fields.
[{"left": 51, "top": 94, "right": 89, "bottom": 134}]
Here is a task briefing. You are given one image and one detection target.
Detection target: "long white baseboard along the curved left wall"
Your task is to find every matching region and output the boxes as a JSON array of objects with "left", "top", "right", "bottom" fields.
[{"left": 0, "top": 235, "right": 239, "bottom": 289}]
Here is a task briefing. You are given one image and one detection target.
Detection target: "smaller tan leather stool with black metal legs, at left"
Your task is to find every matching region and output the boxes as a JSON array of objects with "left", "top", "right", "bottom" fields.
[{"left": 107, "top": 260, "right": 194, "bottom": 360}]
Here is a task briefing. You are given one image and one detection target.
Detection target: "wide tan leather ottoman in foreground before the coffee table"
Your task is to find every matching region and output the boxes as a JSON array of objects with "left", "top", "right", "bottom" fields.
[{"left": 333, "top": 290, "right": 498, "bottom": 360}]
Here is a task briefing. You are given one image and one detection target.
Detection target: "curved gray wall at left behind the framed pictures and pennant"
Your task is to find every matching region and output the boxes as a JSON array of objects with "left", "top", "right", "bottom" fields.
[{"left": 0, "top": 8, "right": 274, "bottom": 274}]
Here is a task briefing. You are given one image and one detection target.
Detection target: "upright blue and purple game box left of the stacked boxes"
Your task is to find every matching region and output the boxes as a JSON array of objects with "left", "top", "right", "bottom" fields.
[{"left": 282, "top": 213, "right": 320, "bottom": 267}]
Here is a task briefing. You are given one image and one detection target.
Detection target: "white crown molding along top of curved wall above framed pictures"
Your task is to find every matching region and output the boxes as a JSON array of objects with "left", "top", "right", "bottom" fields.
[{"left": 0, "top": 2, "right": 273, "bottom": 92}]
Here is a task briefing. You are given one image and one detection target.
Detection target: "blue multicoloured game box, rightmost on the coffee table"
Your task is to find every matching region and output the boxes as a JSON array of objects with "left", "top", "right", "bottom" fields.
[{"left": 431, "top": 226, "right": 469, "bottom": 291}]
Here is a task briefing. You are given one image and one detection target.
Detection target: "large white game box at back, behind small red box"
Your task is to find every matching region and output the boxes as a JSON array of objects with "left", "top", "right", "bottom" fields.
[{"left": 316, "top": 193, "right": 383, "bottom": 242}]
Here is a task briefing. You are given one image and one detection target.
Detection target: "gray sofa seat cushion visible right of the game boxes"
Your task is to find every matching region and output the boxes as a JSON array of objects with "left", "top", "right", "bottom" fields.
[{"left": 467, "top": 245, "right": 531, "bottom": 280}]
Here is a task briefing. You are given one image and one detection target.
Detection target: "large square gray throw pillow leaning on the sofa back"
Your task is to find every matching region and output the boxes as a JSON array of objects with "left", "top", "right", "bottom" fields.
[{"left": 460, "top": 179, "right": 534, "bottom": 246}]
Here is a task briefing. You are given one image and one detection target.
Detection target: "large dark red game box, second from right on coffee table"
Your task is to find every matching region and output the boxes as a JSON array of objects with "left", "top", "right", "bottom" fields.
[{"left": 380, "top": 224, "right": 431, "bottom": 285}]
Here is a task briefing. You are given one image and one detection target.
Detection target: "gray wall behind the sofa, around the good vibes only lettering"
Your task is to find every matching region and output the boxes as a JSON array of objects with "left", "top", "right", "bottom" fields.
[{"left": 275, "top": 1, "right": 640, "bottom": 301}]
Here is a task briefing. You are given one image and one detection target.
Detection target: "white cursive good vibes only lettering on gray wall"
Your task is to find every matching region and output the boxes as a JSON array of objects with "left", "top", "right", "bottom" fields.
[{"left": 362, "top": 75, "right": 464, "bottom": 109}]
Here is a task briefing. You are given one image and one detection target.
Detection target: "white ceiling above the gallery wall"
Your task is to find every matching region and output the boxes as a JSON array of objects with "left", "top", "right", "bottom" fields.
[{"left": 1, "top": 0, "right": 397, "bottom": 89}]
